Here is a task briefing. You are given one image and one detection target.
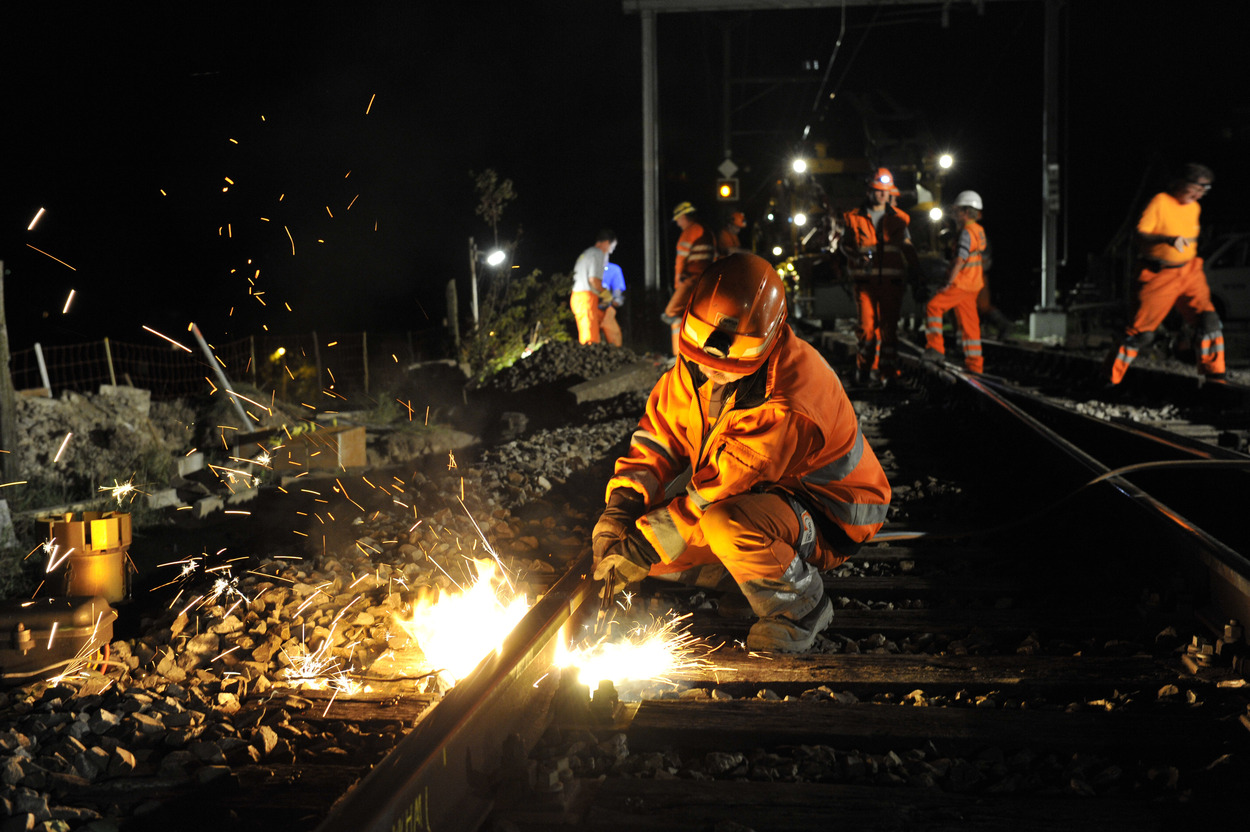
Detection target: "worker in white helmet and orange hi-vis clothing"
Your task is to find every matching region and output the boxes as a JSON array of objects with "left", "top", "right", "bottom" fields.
[{"left": 925, "top": 191, "right": 986, "bottom": 372}]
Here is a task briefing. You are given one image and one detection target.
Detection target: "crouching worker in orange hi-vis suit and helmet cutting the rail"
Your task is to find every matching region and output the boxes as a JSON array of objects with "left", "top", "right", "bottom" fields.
[{"left": 594, "top": 254, "right": 890, "bottom": 652}]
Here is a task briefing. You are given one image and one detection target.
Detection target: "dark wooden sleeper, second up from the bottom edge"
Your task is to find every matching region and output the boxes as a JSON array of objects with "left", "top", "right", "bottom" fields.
[{"left": 628, "top": 700, "right": 1244, "bottom": 760}]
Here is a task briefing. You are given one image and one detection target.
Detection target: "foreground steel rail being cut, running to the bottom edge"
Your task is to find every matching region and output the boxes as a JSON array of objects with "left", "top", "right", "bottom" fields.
[{"left": 318, "top": 552, "right": 598, "bottom": 832}]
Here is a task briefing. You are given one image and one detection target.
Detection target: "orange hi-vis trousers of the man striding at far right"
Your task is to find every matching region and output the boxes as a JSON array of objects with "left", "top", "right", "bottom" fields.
[{"left": 1111, "top": 257, "right": 1224, "bottom": 385}]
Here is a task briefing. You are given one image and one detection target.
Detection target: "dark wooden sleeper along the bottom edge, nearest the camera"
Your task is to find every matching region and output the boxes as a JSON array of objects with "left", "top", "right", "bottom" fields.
[{"left": 555, "top": 777, "right": 1244, "bottom": 832}]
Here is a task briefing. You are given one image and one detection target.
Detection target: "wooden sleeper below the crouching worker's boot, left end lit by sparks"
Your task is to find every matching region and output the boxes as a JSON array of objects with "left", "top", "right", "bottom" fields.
[{"left": 674, "top": 650, "right": 1183, "bottom": 696}]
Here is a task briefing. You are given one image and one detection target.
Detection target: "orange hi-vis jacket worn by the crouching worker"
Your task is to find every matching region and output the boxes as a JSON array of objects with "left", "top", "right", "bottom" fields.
[{"left": 608, "top": 326, "right": 890, "bottom": 563}]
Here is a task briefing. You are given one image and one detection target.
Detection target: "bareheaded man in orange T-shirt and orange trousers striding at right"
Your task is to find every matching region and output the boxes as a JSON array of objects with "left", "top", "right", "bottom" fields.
[{"left": 1109, "top": 164, "right": 1224, "bottom": 385}]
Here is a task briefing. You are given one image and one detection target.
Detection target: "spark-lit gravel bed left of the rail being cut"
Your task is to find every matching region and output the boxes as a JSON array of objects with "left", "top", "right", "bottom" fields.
[{"left": 0, "top": 454, "right": 610, "bottom": 831}]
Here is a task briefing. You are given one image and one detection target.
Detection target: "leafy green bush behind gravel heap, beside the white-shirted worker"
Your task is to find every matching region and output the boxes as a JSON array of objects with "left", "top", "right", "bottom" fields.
[{"left": 461, "top": 269, "right": 573, "bottom": 380}]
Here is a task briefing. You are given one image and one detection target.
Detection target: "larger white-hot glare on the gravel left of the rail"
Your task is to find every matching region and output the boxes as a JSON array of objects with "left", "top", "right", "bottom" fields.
[{"left": 396, "top": 558, "right": 529, "bottom": 681}]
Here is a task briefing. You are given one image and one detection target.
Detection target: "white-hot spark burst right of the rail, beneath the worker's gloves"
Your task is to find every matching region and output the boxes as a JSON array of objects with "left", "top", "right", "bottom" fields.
[{"left": 556, "top": 613, "right": 710, "bottom": 682}]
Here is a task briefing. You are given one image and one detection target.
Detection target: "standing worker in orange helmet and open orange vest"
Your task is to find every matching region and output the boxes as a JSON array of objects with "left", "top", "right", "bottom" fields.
[{"left": 840, "top": 167, "right": 919, "bottom": 385}]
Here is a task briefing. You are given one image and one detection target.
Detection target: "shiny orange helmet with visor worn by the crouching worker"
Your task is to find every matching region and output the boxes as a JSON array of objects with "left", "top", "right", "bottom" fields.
[{"left": 678, "top": 254, "right": 786, "bottom": 374}]
